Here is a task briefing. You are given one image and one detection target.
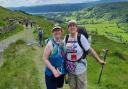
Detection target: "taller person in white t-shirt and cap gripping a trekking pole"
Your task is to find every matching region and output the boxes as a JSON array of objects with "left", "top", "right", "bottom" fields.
[{"left": 64, "top": 20, "right": 105, "bottom": 89}]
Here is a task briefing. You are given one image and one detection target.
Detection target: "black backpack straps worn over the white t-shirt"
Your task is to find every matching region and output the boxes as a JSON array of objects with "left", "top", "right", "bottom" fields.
[{"left": 65, "top": 33, "right": 88, "bottom": 59}]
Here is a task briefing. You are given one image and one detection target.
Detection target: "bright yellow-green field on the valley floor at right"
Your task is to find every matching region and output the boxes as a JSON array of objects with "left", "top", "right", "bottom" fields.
[{"left": 85, "top": 23, "right": 128, "bottom": 44}]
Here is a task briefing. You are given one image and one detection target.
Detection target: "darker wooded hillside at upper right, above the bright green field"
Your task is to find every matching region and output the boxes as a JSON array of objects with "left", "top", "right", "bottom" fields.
[{"left": 77, "top": 2, "right": 128, "bottom": 22}]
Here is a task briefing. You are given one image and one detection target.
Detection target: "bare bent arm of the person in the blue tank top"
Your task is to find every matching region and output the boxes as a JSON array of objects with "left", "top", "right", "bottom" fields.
[{"left": 43, "top": 43, "right": 60, "bottom": 77}]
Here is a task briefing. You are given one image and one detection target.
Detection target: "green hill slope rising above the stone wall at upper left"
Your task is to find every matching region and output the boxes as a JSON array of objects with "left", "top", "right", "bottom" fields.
[{"left": 0, "top": 7, "right": 52, "bottom": 29}]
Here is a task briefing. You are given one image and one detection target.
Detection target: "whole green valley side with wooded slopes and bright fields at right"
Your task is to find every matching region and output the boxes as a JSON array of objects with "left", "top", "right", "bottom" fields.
[{"left": 42, "top": 2, "right": 128, "bottom": 44}]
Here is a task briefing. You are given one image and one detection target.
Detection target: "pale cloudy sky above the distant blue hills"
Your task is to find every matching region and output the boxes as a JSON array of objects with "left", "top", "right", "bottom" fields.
[{"left": 0, "top": 0, "right": 99, "bottom": 7}]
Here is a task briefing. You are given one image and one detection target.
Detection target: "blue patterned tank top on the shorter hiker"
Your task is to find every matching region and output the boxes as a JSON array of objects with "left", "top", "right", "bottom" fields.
[{"left": 45, "top": 39, "right": 65, "bottom": 76}]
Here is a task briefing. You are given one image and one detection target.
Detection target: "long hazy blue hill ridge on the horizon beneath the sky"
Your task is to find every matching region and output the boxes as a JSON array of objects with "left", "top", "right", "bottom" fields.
[{"left": 10, "top": 0, "right": 128, "bottom": 13}]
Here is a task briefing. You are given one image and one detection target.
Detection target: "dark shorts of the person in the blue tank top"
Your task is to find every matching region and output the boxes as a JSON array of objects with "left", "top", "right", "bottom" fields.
[{"left": 45, "top": 75, "right": 64, "bottom": 89}]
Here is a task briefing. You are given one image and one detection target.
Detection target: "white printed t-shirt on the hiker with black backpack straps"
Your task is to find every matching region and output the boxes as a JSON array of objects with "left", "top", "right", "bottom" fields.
[{"left": 64, "top": 34, "right": 90, "bottom": 75}]
